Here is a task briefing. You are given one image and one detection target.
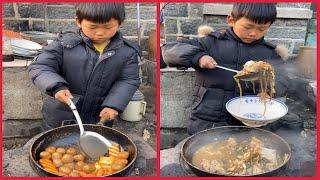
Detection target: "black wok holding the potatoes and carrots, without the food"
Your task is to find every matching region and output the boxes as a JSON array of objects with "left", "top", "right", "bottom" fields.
[{"left": 29, "top": 124, "right": 137, "bottom": 176}]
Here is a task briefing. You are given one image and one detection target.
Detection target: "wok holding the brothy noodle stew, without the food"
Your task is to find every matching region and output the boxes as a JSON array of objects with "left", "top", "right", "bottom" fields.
[{"left": 180, "top": 126, "right": 291, "bottom": 176}]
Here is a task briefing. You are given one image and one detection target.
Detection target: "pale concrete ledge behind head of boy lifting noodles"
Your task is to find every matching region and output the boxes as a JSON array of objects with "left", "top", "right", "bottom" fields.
[{"left": 203, "top": 3, "right": 312, "bottom": 19}]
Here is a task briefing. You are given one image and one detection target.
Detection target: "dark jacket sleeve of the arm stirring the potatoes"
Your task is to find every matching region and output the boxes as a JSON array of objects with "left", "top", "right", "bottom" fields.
[{"left": 28, "top": 41, "right": 68, "bottom": 96}]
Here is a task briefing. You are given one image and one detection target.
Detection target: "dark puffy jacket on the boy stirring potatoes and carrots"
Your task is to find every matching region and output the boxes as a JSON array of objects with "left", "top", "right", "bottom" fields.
[{"left": 29, "top": 30, "right": 140, "bottom": 129}]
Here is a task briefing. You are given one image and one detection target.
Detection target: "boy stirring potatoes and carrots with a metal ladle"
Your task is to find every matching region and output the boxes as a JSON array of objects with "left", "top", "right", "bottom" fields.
[{"left": 29, "top": 3, "right": 140, "bottom": 130}]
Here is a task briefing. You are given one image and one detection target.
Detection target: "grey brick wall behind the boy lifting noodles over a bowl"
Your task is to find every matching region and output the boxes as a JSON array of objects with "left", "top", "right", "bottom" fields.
[{"left": 161, "top": 3, "right": 312, "bottom": 55}]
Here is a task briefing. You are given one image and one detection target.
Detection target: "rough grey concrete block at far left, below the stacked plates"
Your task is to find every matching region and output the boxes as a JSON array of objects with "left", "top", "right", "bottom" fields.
[{"left": 2, "top": 67, "right": 43, "bottom": 120}]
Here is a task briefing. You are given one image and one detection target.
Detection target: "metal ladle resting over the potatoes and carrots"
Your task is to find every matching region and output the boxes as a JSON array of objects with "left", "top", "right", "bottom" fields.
[{"left": 69, "top": 99, "right": 112, "bottom": 159}]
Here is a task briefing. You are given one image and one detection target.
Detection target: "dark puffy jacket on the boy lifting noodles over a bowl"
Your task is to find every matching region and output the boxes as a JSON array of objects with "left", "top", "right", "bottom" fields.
[{"left": 161, "top": 28, "right": 286, "bottom": 134}]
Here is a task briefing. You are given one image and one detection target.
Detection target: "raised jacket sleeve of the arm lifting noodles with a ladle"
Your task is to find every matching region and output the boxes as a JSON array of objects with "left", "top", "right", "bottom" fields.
[{"left": 161, "top": 39, "right": 208, "bottom": 68}]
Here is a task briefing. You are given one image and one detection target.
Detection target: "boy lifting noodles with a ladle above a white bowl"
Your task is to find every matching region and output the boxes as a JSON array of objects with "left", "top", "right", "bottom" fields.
[{"left": 162, "top": 3, "right": 285, "bottom": 134}]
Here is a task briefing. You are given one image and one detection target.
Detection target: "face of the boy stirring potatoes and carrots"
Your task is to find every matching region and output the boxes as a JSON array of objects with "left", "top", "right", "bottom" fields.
[{"left": 77, "top": 18, "right": 120, "bottom": 44}]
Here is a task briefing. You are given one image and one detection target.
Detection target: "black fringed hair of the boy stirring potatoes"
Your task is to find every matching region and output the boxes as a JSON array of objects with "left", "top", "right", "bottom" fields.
[{"left": 75, "top": 3, "right": 125, "bottom": 24}]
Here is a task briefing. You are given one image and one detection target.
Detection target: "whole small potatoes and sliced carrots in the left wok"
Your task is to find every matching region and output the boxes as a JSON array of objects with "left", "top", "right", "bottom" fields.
[{"left": 39, "top": 143, "right": 129, "bottom": 177}]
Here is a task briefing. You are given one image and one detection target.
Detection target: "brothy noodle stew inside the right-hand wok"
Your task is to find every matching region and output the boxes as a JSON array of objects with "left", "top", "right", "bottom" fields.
[{"left": 192, "top": 136, "right": 289, "bottom": 176}]
